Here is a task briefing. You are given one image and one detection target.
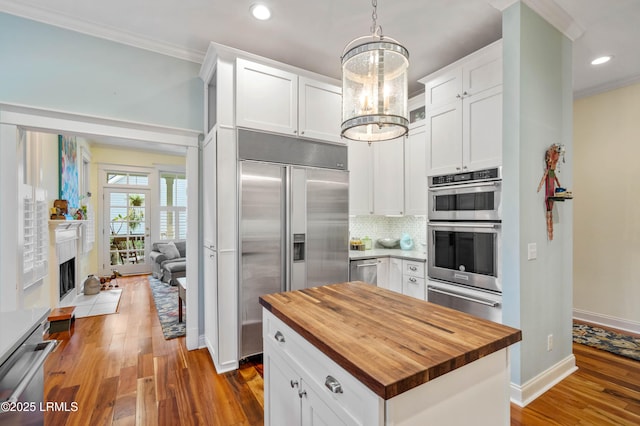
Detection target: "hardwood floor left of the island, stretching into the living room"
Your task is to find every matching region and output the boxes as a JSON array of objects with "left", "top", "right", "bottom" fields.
[{"left": 45, "top": 276, "right": 263, "bottom": 426}]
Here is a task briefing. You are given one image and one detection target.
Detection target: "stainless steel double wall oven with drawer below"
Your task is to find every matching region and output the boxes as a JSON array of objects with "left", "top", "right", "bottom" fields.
[{"left": 427, "top": 168, "right": 502, "bottom": 322}]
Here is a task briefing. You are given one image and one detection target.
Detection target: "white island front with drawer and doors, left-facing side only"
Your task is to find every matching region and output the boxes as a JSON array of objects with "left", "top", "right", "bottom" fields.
[{"left": 263, "top": 310, "right": 384, "bottom": 426}]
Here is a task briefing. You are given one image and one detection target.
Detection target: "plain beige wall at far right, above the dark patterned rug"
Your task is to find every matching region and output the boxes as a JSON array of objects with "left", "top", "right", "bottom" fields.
[{"left": 573, "top": 84, "right": 640, "bottom": 333}]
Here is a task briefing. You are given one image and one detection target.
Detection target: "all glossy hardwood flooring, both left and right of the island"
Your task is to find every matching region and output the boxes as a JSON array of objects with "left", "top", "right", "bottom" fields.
[{"left": 45, "top": 276, "right": 640, "bottom": 426}]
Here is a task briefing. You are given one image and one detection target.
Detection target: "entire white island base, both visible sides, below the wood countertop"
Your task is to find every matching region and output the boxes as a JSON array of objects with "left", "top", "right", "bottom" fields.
[{"left": 263, "top": 309, "right": 510, "bottom": 426}]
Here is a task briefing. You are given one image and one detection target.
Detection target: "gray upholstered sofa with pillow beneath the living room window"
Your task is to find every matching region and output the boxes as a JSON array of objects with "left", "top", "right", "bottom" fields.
[{"left": 149, "top": 240, "right": 187, "bottom": 285}]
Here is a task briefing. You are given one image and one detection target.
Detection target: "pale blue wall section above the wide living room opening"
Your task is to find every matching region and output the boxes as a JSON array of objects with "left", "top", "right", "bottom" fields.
[{"left": 0, "top": 13, "right": 204, "bottom": 131}]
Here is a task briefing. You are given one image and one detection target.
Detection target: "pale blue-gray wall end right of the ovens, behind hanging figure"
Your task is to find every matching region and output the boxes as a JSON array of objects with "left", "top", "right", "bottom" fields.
[{"left": 503, "top": 2, "right": 573, "bottom": 385}]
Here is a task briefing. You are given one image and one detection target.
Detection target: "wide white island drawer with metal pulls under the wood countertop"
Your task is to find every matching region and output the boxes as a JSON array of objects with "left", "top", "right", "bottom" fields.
[{"left": 263, "top": 310, "right": 384, "bottom": 425}]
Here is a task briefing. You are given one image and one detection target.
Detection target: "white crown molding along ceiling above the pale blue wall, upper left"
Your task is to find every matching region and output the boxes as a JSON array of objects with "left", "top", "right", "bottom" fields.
[{"left": 0, "top": 0, "right": 205, "bottom": 64}]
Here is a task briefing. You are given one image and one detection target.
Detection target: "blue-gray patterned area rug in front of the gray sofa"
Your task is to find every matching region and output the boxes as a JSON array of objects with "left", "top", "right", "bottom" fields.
[{"left": 148, "top": 275, "right": 187, "bottom": 340}]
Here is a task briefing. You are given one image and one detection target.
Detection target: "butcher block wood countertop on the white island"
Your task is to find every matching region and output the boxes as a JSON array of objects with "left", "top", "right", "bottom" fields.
[{"left": 260, "top": 281, "right": 522, "bottom": 399}]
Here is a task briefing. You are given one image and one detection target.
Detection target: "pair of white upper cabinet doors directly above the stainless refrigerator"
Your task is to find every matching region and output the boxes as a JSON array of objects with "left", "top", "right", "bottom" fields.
[{"left": 236, "top": 58, "right": 342, "bottom": 143}]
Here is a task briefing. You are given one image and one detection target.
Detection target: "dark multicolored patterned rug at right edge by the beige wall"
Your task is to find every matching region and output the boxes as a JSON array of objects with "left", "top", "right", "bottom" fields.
[{"left": 573, "top": 323, "right": 640, "bottom": 361}]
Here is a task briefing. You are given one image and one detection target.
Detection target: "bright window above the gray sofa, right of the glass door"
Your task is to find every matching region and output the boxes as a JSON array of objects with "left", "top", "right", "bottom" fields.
[{"left": 159, "top": 172, "right": 187, "bottom": 240}]
